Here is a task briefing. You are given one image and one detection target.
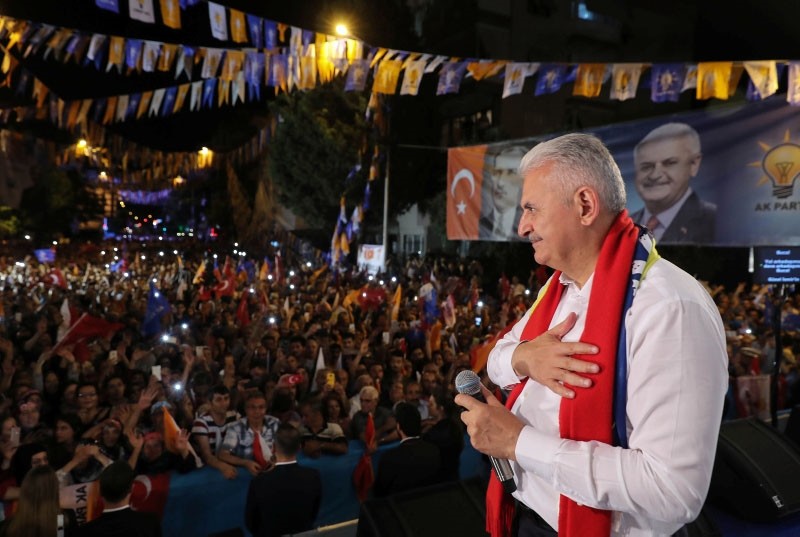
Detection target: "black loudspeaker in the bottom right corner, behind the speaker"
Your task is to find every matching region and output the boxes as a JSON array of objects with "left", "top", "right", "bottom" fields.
[{"left": 708, "top": 418, "right": 800, "bottom": 522}]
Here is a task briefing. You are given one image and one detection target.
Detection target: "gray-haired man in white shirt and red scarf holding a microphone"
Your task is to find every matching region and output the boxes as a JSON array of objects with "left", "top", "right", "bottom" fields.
[{"left": 456, "top": 134, "right": 728, "bottom": 537}]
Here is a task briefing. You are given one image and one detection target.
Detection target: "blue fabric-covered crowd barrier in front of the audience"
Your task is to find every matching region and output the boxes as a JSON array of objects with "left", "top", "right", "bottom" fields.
[{"left": 162, "top": 436, "right": 488, "bottom": 536}]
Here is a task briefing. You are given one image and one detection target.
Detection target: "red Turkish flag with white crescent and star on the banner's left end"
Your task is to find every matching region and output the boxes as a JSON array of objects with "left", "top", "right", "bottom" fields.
[{"left": 447, "top": 145, "right": 487, "bottom": 240}]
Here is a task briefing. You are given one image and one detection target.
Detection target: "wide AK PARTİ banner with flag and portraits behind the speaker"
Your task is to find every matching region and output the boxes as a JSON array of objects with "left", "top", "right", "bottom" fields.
[{"left": 447, "top": 95, "right": 800, "bottom": 247}]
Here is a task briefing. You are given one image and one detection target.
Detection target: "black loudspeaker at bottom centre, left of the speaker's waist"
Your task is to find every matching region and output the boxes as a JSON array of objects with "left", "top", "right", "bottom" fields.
[{"left": 357, "top": 478, "right": 486, "bottom": 537}]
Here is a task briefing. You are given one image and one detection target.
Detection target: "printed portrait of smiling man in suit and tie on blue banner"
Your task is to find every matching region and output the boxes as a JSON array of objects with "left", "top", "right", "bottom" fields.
[{"left": 631, "top": 123, "right": 717, "bottom": 244}]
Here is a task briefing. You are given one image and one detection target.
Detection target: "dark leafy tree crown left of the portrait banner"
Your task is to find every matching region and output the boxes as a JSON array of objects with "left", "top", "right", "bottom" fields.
[{"left": 269, "top": 81, "right": 368, "bottom": 227}]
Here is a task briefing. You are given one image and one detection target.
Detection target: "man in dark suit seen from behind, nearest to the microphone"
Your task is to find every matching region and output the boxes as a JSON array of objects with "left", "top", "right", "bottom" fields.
[{"left": 372, "top": 403, "right": 441, "bottom": 497}]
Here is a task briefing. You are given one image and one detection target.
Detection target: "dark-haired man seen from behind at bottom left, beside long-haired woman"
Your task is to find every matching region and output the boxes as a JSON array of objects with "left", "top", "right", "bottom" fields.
[{"left": 75, "top": 461, "right": 161, "bottom": 537}]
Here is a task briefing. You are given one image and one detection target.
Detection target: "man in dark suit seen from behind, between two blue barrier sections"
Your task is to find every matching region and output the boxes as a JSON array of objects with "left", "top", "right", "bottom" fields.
[{"left": 244, "top": 423, "right": 322, "bottom": 537}]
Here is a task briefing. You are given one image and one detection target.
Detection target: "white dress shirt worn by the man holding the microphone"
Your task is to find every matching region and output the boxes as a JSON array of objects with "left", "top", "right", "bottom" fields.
[{"left": 488, "top": 259, "right": 728, "bottom": 537}]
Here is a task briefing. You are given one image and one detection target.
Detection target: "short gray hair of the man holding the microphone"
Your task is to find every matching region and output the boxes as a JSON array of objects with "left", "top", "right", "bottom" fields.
[{"left": 519, "top": 133, "right": 626, "bottom": 214}]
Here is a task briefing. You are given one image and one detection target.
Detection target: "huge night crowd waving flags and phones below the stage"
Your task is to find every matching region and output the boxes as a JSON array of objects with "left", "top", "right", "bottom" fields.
[{"left": 0, "top": 237, "right": 800, "bottom": 532}]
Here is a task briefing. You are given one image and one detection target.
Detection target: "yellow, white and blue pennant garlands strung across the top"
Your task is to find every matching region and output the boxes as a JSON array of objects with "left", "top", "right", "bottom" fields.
[{"left": 0, "top": 8, "right": 798, "bottom": 109}]
